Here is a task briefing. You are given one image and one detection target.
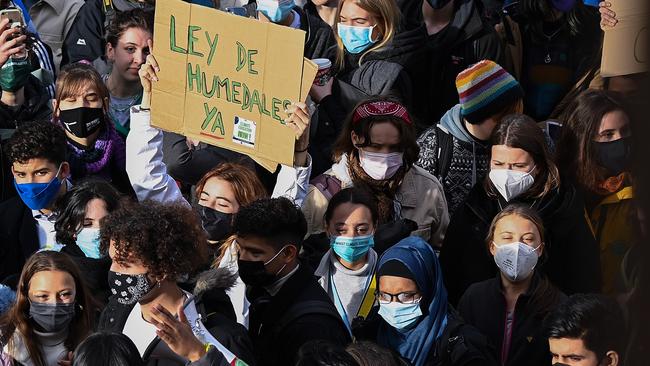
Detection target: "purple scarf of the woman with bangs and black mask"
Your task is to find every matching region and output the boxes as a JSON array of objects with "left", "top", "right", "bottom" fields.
[{"left": 63, "top": 119, "right": 126, "bottom": 175}]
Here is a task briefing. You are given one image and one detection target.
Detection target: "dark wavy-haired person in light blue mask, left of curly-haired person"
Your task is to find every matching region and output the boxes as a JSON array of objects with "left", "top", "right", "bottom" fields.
[{"left": 54, "top": 180, "right": 121, "bottom": 303}]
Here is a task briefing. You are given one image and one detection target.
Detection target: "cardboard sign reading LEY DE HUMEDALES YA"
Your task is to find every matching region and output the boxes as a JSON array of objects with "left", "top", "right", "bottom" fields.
[{"left": 151, "top": 0, "right": 315, "bottom": 165}]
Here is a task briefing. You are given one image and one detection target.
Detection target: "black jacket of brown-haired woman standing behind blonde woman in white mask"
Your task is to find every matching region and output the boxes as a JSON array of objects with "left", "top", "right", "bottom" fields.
[{"left": 440, "top": 183, "right": 601, "bottom": 304}]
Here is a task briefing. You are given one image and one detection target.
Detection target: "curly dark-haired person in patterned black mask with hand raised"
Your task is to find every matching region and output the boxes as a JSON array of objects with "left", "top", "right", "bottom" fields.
[{"left": 98, "top": 201, "right": 254, "bottom": 366}]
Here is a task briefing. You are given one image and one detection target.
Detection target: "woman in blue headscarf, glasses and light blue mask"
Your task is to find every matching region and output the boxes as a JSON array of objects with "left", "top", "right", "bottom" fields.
[{"left": 355, "top": 236, "right": 496, "bottom": 366}]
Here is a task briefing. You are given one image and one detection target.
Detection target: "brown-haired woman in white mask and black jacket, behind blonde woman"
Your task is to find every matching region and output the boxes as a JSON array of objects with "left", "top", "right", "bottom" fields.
[{"left": 440, "top": 115, "right": 600, "bottom": 304}]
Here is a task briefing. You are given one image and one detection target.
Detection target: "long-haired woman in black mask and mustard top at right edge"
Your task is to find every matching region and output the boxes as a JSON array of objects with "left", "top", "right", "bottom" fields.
[{"left": 556, "top": 90, "right": 635, "bottom": 294}]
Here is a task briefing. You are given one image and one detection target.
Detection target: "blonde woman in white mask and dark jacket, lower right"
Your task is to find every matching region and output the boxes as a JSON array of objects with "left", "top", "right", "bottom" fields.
[{"left": 458, "top": 204, "right": 566, "bottom": 366}]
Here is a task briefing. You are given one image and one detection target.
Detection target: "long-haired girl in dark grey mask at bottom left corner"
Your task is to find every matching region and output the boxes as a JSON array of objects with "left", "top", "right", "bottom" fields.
[{"left": 0, "top": 251, "right": 96, "bottom": 365}]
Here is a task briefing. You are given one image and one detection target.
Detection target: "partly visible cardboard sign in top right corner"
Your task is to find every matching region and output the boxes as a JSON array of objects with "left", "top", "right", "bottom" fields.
[{"left": 600, "top": 0, "right": 650, "bottom": 77}]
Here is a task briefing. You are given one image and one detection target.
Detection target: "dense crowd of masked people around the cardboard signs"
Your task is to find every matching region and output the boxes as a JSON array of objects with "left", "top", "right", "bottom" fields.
[{"left": 0, "top": 0, "right": 650, "bottom": 366}]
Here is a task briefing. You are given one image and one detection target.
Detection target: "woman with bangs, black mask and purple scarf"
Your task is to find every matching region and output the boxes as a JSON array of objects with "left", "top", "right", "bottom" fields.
[{"left": 52, "top": 64, "right": 133, "bottom": 194}]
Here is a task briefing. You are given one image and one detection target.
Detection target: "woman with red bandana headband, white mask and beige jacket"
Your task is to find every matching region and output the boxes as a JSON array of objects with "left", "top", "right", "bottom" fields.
[{"left": 276, "top": 97, "right": 449, "bottom": 255}]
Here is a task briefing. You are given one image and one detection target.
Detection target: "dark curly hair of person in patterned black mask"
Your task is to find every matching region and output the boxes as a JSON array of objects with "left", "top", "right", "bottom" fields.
[{"left": 100, "top": 201, "right": 207, "bottom": 280}]
